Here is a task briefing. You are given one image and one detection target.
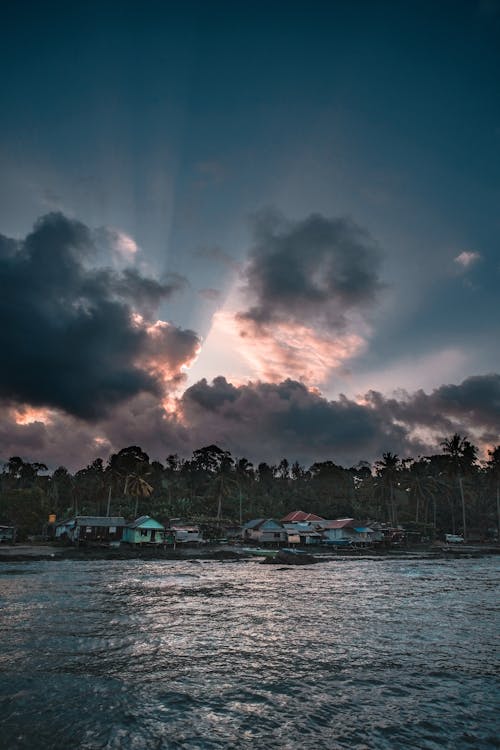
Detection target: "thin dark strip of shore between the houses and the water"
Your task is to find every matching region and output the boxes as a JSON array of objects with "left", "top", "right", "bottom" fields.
[{"left": 0, "top": 543, "right": 500, "bottom": 563}]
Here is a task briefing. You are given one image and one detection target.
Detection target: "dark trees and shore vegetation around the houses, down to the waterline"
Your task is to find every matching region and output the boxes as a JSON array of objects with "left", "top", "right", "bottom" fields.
[{"left": 0, "top": 434, "right": 500, "bottom": 559}]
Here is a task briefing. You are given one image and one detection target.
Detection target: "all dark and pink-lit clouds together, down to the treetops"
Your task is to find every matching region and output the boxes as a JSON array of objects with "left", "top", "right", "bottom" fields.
[{"left": 0, "top": 214, "right": 500, "bottom": 468}]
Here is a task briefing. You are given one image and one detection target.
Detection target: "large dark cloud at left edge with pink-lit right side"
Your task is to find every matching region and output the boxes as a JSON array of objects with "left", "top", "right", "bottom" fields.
[{"left": 0, "top": 213, "right": 199, "bottom": 419}]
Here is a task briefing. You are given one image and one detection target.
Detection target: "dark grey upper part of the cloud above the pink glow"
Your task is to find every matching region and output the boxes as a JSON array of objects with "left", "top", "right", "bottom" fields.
[{"left": 240, "top": 211, "right": 382, "bottom": 330}]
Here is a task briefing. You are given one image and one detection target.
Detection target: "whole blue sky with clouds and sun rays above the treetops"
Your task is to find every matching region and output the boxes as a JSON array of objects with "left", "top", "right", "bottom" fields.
[{"left": 0, "top": 0, "right": 500, "bottom": 469}]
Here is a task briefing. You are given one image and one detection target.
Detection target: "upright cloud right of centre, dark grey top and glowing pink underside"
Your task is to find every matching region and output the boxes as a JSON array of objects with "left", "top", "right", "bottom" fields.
[{"left": 204, "top": 210, "right": 383, "bottom": 386}]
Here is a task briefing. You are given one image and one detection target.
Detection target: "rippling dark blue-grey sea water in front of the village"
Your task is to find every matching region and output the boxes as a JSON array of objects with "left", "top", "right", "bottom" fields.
[{"left": 0, "top": 558, "right": 500, "bottom": 750}]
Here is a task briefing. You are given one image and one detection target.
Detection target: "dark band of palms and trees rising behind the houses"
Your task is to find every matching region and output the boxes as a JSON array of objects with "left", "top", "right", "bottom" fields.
[{"left": 0, "top": 434, "right": 500, "bottom": 538}]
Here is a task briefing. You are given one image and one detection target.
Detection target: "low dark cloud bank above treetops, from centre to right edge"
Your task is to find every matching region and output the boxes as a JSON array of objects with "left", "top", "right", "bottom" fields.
[{"left": 181, "top": 374, "right": 500, "bottom": 464}]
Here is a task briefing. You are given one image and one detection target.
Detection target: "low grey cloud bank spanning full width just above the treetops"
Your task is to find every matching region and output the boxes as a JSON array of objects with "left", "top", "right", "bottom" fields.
[{"left": 0, "top": 374, "right": 500, "bottom": 468}]
